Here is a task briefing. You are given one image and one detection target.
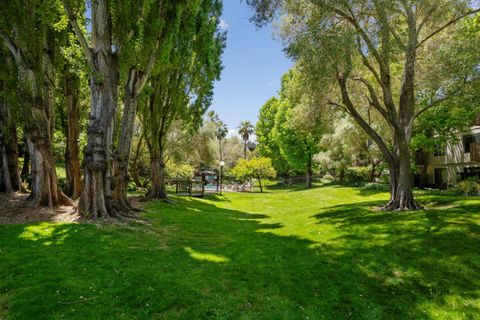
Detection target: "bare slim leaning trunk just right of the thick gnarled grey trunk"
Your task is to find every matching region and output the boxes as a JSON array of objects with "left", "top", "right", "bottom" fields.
[{"left": 113, "top": 87, "right": 138, "bottom": 210}]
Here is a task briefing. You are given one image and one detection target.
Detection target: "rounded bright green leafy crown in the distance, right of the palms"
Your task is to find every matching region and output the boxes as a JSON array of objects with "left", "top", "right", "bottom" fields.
[{"left": 257, "top": 69, "right": 325, "bottom": 173}]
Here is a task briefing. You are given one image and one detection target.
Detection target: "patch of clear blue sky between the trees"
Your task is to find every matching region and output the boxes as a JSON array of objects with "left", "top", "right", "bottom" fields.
[{"left": 210, "top": 0, "right": 292, "bottom": 130}]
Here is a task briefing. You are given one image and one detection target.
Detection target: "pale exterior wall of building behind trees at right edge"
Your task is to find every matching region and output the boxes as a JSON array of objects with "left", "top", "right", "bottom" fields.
[{"left": 427, "top": 126, "right": 480, "bottom": 187}]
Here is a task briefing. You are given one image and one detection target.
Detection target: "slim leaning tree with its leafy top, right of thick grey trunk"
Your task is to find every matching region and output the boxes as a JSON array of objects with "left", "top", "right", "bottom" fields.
[{"left": 113, "top": 0, "right": 175, "bottom": 210}]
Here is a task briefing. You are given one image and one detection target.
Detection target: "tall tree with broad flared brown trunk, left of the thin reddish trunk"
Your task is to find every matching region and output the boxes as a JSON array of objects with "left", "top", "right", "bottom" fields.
[{"left": 0, "top": 0, "right": 70, "bottom": 207}]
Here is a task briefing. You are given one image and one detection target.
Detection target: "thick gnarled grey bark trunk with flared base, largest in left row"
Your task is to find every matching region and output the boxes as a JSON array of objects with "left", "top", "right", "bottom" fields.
[{"left": 76, "top": 1, "right": 123, "bottom": 219}]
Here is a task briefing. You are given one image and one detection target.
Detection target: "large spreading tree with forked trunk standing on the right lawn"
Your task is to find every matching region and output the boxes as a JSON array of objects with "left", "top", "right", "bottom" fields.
[{"left": 248, "top": 0, "right": 480, "bottom": 210}]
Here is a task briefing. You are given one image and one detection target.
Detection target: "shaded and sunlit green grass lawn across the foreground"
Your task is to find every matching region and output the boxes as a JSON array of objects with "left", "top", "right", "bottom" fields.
[{"left": 0, "top": 186, "right": 480, "bottom": 319}]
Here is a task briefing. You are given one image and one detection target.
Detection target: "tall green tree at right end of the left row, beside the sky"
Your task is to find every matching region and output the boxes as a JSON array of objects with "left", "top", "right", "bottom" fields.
[{"left": 139, "top": 0, "right": 225, "bottom": 199}]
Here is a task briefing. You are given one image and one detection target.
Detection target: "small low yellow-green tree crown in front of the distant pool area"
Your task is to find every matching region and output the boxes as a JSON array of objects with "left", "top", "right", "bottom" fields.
[{"left": 231, "top": 158, "right": 277, "bottom": 182}]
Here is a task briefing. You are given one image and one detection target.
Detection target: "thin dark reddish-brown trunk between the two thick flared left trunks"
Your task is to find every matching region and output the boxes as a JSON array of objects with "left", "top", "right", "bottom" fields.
[{"left": 64, "top": 76, "right": 82, "bottom": 199}]
